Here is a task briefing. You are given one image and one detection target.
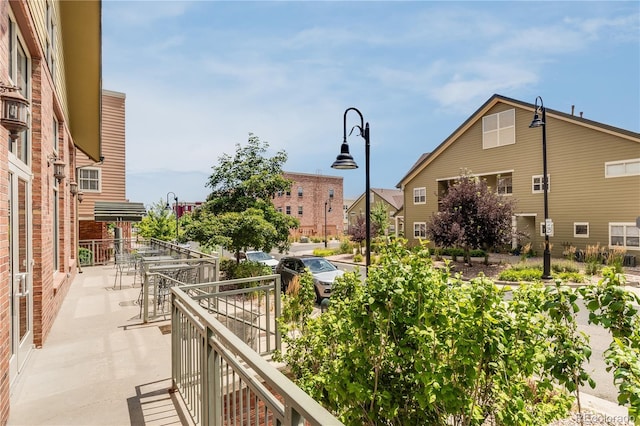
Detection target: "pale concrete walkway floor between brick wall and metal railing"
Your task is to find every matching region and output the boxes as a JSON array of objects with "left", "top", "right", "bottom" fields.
[{"left": 8, "top": 265, "right": 190, "bottom": 426}]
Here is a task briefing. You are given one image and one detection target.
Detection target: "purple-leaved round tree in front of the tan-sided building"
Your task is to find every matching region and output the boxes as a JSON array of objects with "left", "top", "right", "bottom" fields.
[{"left": 427, "top": 173, "right": 514, "bottom": 263}]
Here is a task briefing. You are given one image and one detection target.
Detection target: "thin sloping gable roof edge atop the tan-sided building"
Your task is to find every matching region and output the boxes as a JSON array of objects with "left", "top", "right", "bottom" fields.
[{"left": 396, "top": 94, "right": 640, "bottom": 188}]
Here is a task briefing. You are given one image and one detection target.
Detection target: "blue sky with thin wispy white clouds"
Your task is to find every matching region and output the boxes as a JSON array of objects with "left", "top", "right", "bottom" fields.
[{"left": 102, "top": 0, "right": 640, "bottom": 206}]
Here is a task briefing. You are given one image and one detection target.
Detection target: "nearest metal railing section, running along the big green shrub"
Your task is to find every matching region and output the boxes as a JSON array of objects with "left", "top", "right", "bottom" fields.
[{"left": 171, "top": 275, "right": 342, "bottom": 426}]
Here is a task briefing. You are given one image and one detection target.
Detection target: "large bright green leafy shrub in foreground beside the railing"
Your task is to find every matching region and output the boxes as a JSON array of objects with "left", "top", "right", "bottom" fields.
[{"left": 274, "top": 240, "right": 593, "bottom": 425}]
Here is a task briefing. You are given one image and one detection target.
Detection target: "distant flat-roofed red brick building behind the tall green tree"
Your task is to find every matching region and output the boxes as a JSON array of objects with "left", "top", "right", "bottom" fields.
[{"left": 273, "top": 172, "right": 343, "bottom": 238}]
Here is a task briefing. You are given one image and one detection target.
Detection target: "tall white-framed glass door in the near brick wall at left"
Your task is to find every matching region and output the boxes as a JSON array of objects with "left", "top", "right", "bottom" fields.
[{"left": 9, "top": 170, "right": 33, "bottom": 383}]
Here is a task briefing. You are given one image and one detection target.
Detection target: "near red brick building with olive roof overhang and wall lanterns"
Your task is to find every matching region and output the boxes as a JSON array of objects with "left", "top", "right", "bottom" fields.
[{"left": 0, "top": 0, "right": 102, "bottom": 425}]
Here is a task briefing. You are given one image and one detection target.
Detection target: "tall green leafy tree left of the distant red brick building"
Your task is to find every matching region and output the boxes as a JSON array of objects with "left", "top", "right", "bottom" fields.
[{"left": 185, "top": 133, "right": 299, "bottom": 253}]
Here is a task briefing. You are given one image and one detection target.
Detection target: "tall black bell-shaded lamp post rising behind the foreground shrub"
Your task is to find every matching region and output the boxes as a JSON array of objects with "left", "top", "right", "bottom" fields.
[{"left": 331, "top": 107, "right": 371, "bottom": 272}]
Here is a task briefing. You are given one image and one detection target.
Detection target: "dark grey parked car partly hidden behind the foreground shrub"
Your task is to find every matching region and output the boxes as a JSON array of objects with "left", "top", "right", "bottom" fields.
[{"left": 276, "top": 256, "right": 344, "bottom": 303}]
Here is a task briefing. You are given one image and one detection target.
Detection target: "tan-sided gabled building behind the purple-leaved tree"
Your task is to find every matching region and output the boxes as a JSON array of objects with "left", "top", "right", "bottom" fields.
[{"left": 398, "top": 95, "right": 640, "bottom": 257}]
